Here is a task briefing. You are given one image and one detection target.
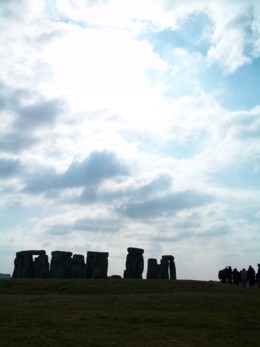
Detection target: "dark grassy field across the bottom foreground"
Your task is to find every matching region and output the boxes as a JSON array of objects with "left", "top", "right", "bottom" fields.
[{"left": 0, "top": 279, "right": 260, "bottom": 347}]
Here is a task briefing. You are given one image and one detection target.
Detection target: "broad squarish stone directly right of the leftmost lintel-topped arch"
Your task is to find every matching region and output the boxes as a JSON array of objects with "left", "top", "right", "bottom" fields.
[{"left": 50, "top": 251, "right": 72, "bottom": 278}]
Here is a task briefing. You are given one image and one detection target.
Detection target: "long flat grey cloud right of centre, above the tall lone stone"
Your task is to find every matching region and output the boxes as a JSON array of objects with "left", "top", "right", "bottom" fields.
[{"left": 118, "top": 191, "right": 213, "bottom": 219}]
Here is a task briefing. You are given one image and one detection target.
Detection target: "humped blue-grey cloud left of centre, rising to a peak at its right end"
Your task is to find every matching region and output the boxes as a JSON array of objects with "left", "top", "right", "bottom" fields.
[{"left": 25, "top": 151, "right": 128, "bottom": 193}]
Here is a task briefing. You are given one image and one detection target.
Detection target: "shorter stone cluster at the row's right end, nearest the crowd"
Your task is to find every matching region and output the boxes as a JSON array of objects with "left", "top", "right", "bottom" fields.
[{"left": 146, "top": 255, "right": 176, "bottom": 280}]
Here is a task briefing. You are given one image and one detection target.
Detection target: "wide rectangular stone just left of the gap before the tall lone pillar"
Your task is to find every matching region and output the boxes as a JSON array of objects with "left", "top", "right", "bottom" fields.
[{"left": 87, "top": 251, "right": 109, "bottom": 278}]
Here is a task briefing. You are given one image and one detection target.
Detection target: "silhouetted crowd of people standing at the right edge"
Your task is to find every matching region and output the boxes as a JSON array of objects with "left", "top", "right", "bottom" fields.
[{"left": 218, "top": 264, "right": 260, "bottom": 287}]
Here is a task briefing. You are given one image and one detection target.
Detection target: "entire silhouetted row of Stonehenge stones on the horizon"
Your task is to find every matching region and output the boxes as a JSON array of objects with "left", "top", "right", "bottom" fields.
[{"left": 12, "top": 247, "right": 176, "bottom": 280}]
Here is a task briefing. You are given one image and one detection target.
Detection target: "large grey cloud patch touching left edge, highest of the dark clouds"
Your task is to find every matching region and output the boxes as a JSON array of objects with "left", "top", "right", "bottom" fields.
[{"left": 0, "top": 85, "right": 66, "bottom": 153}]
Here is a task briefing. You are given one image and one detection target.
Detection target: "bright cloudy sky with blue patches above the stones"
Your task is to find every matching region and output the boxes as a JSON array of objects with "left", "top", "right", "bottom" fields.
[{"left": 0, "top": 0, "right": 260, "bottom": 280}]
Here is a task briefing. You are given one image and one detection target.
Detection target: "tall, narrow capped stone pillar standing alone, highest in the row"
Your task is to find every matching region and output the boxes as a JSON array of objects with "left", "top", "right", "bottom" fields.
[{"left": 124, "top": 247, "right": 144, "bottom": 279}]
